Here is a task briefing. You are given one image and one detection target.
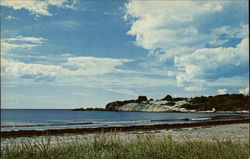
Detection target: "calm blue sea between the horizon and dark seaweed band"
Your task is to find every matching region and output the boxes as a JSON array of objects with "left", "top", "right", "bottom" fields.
[{"left": 1, "top": 109, "right": 248, "bottom": 131}]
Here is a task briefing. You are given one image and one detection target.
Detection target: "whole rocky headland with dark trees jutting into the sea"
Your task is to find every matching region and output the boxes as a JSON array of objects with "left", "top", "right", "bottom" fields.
[{"left": 73, "top": 94, "right": 250, "bottom": 113}]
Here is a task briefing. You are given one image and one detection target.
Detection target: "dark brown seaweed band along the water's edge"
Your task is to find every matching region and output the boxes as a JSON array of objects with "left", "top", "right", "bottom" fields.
[{"left": 1, "top": 119, "right": 250, "bottom": 139}]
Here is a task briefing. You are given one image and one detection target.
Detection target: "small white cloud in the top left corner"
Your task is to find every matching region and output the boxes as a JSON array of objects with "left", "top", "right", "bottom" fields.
[{"left": 1, "top": 0, "right": 77, "bottom": 16}]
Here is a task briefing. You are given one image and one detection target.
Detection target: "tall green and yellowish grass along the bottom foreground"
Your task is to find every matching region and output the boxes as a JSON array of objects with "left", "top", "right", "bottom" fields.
[{"left": 1, "top": 135, "right": 250, "bottom": 159}]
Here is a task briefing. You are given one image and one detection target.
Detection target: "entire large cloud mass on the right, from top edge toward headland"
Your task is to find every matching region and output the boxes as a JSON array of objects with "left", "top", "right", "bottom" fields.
[{"left": 124, "top": 1, "right": 249, "bottom": 91}]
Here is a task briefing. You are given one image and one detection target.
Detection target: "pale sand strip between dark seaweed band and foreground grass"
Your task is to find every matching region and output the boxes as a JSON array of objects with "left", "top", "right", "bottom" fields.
[{"left": 1, "top": 123, "right": 249, "bottom": 146}]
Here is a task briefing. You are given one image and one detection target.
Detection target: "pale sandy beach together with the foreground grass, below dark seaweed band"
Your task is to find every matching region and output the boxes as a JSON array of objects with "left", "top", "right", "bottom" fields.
[{"left": 1, "top": 122, "right": 250, "bottom": 159}]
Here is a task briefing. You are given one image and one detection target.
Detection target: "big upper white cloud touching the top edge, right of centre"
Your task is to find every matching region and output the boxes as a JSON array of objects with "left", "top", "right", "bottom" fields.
[{"left": 125, "top": 1, "right": 224, "bottom": 54}]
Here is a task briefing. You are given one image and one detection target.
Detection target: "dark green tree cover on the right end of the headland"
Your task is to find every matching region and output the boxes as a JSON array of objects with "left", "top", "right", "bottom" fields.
[{"left": 181, "top": 94, "right": 250, "bottom": 111}]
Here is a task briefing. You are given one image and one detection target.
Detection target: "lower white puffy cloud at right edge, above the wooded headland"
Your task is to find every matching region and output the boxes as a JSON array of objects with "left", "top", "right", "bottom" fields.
[{"left": 174, "top": 38, "right": 249, "bottom": 85}]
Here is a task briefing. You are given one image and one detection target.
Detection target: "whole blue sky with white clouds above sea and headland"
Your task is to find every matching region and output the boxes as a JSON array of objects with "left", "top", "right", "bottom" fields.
[{"left": 1, "top": 0, "right": 249, "bottom": 109}]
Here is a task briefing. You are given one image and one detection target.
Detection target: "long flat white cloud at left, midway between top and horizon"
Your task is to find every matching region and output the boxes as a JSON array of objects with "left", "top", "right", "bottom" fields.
[{"left": 1, "top": 57, "right": 131, "bottom": 79}]
